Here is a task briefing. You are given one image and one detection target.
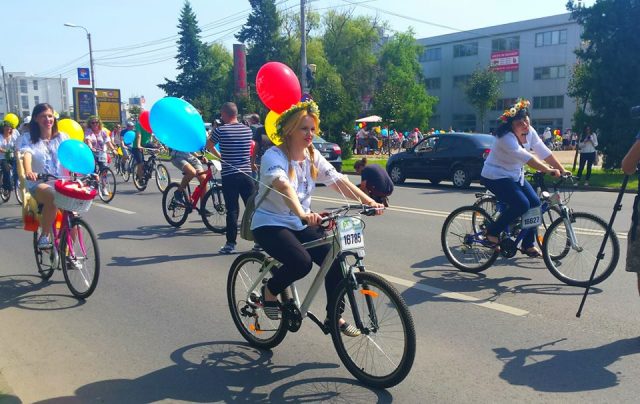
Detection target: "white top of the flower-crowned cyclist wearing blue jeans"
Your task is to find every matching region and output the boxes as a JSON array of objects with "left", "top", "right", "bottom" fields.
[{"left": 481, "top": 128, "right": 551, "bottom": 183}]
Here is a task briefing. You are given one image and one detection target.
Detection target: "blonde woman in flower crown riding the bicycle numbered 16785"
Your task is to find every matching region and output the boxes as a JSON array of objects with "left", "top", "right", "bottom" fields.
[{"left": 251, "top": 101, "right": 383, "bottom": 337}]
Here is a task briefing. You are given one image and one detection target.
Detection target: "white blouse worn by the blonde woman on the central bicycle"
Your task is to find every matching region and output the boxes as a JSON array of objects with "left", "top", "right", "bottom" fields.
[{"left": 251, "top": 146, "right": 343, "bottom": 231}]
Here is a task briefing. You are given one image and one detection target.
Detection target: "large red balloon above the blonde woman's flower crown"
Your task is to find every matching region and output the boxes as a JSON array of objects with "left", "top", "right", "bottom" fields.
[{"left": 256, "top": 62, "right": 302, "bottom": 114}]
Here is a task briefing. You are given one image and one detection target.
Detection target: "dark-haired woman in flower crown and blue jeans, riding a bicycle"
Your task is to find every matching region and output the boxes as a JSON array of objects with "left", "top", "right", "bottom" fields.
[{"left": 481, "top": 99, "right": 566, "bottom": 257}]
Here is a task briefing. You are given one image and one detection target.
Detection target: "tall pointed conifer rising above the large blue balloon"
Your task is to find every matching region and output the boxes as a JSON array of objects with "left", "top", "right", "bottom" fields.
[{"left": 158, "top": 0, "right": 205, "bottom": 101}]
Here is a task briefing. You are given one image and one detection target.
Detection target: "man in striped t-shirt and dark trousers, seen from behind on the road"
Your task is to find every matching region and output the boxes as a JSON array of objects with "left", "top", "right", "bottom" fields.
[{"left": 207, "top": 102, "right": 254, "bottom": 254}]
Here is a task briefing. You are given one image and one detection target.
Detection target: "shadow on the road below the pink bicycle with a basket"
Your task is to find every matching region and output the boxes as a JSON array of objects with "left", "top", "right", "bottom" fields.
[{"left": 0, "top": 275, "right": 85, "bottom": 311}]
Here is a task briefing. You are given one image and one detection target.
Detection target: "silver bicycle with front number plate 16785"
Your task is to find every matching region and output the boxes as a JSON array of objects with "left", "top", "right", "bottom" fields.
[{"left": 227, "top": 206, "right": 416, "bottom": 388}]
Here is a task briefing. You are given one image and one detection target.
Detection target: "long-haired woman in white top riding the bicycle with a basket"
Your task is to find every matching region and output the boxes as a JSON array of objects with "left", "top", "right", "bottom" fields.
[{"left": 20, "top": 103, "right": 69, "bottom": 248}]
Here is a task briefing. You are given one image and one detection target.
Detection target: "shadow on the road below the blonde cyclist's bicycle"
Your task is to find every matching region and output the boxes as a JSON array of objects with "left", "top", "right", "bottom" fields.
[{"left": 40, "top": 341, "right": 392, "bottom": 403}]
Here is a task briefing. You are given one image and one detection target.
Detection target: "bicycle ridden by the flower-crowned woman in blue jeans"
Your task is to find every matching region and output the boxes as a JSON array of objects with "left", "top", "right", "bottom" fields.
[{"left": 440, "top": 177, "right": 620, "bottom": 286}]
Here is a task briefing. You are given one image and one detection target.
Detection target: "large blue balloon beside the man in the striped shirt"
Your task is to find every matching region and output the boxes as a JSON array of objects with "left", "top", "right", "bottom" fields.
[{"left": 149, "top": 97, "right": 207, "bottom": 152}]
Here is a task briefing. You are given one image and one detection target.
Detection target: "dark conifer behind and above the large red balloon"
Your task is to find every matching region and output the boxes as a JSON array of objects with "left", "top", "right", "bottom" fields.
[{"left": 236, "top": 0, "right": 286, "bottom": 81}]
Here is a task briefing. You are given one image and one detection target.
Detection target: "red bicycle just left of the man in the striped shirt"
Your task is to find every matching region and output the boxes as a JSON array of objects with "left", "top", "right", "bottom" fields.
[{"left": 162, "top": 160, "right": 227, "bottom": 233}]
